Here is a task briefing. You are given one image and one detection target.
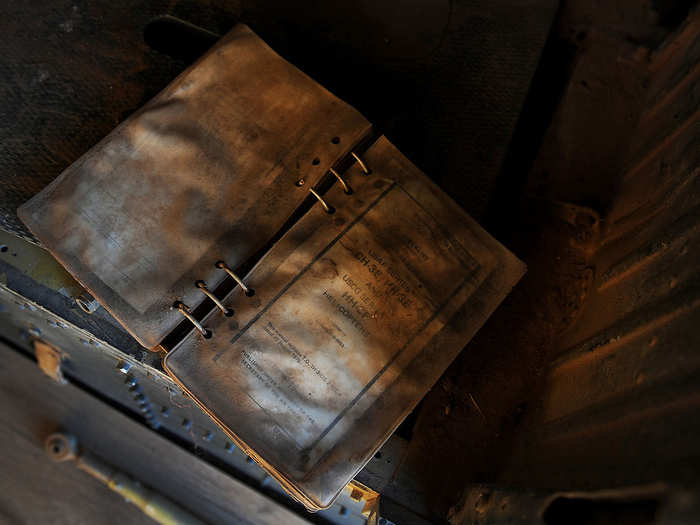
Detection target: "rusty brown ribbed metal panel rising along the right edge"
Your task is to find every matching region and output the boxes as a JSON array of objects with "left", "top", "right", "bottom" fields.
[{"left": 520, "top": 8, "right": 700, "bottom": 482}]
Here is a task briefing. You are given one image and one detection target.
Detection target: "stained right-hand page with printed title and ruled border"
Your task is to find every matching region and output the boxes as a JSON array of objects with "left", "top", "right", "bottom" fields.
[{"left": 165, "top": 135, "right": 524, "bottom": 508}]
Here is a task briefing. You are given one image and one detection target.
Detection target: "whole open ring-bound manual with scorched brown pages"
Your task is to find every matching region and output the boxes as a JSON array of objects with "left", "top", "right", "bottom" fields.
[{"left": 19, "top": 25, "right": 524, "bottom": 510}]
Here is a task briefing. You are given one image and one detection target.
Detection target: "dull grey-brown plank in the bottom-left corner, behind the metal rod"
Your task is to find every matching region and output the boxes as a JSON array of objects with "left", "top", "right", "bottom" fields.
[{"left": 0, "top": 344, "right": 307, "bottom": 525}]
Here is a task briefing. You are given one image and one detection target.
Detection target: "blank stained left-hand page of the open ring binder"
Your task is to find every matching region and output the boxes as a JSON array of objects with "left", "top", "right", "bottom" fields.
[{"left": 19, "top": 25, "right": 370, "bottom": 347}]
